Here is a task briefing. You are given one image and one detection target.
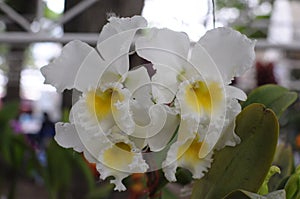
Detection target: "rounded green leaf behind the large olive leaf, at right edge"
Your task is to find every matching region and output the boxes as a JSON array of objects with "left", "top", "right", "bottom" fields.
[{"left": 242, "top": 84, "right": 298, "bottom": 118}]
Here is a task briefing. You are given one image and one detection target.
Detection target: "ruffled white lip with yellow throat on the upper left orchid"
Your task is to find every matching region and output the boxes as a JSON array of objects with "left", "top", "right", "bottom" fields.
[{"left": 77, "top": 83, "right": 135, "bottom": 134}]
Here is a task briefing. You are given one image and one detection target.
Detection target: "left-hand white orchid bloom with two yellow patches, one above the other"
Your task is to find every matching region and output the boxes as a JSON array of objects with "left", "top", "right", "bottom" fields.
[{"left": 41, "top": 16, "right": 154, "bottom": 191}]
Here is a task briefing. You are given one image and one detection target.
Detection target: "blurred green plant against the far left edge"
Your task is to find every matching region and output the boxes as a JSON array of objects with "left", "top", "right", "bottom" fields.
[{"left": 0, "top": 102, "right": 39, "bottom": 199}]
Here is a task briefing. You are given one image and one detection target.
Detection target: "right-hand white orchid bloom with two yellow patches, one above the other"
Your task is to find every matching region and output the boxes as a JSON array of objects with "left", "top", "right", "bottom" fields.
[{"left": 136, "top": 28, "right": 255, "bottom": 181}]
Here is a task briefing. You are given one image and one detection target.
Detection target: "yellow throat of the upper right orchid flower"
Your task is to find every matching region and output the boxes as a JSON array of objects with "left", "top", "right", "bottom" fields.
[{"left": 185, "top": 81, "right": 223, "bottom": 113}]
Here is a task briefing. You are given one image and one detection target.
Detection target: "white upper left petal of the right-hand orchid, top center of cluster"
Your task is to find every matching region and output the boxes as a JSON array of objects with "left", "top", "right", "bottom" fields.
[{"left": 135, "top": 28, "right": 190, "bottom": 73}]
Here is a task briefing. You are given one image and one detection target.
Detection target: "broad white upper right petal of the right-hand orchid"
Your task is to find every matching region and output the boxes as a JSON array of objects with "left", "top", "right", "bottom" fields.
[{"left": 198, "top": 28, "right": 255, "bottom": 83}]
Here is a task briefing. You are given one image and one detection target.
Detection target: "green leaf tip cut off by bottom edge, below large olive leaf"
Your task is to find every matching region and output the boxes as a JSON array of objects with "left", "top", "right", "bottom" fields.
[{"left": 224, "top": 190, "right": 286, "bottom": 199}]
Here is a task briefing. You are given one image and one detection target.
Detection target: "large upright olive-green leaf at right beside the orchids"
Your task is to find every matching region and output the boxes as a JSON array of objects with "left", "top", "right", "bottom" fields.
[{"left": 192, "top": 104, "right": 279, "bottom": 199}]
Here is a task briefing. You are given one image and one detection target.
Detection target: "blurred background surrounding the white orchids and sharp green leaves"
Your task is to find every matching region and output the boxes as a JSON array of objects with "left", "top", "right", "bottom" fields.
[{"left": 0, "top": 0, "right": 300, "bottom": 199}]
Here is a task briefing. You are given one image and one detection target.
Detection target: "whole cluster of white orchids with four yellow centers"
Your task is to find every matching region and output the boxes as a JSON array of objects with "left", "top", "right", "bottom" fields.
[{"left": 41, "top": 16, "right": 255, "bottom": 191}]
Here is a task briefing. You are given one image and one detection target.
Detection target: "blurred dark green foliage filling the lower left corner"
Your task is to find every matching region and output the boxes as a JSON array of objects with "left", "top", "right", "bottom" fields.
[{"left": 0, "top": 102, "right": 112, "bottom": 199}]
